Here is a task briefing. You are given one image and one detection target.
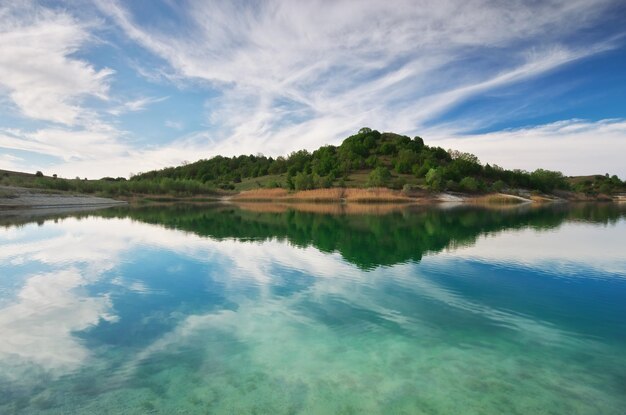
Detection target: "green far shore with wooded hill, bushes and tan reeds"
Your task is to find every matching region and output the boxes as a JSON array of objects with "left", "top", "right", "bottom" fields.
[{"left": 0, "top": 128, "right": 626, "bottom": 201}]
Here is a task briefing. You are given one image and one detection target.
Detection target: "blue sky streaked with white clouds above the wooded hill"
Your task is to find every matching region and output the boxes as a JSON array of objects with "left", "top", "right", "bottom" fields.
[{"left": 0, "top": 0, "right": 626, "bottom": 179}]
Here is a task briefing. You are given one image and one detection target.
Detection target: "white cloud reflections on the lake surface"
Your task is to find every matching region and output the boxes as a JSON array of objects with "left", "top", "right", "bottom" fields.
[{"left": 0, "top": 214, "right": 626, "bottom": 386}]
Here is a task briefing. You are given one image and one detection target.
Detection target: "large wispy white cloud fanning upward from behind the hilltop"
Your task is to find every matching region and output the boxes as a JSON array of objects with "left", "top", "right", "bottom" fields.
[{"left": 97, "top": 0, "right": 615, "bottom": 161}]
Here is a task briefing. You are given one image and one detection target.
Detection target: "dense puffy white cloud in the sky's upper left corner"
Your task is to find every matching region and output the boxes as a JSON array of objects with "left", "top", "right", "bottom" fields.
[{"left": 0, "top": 3, "right": 113, "bottom": 125}]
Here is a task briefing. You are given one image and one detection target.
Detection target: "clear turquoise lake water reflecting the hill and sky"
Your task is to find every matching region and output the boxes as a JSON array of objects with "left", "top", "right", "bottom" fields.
[{"left": 0, "top": 205, "right": 626, "bottom": 414}]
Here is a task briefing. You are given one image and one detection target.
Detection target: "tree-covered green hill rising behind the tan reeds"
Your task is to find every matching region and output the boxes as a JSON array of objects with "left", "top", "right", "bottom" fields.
[{"left": 131, "top": 128, "right": 624, "bottom": 194}]
